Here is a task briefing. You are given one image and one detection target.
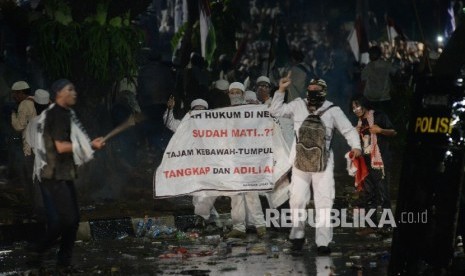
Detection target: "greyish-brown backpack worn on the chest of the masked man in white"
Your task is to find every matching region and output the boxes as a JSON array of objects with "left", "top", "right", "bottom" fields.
[{"left": 294, "top": 105, "right": 335, "bottom": 172}]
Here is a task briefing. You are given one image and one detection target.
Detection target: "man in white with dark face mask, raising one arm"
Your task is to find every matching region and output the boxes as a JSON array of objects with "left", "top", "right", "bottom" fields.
[{"left": 270, "top": 73, "right": 361, "bottom": 255}]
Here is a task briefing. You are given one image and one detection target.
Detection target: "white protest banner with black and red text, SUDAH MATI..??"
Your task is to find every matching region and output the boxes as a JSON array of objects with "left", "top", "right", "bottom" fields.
[{"left": 153, "top": 105, "right": 290, "bottom": 198}]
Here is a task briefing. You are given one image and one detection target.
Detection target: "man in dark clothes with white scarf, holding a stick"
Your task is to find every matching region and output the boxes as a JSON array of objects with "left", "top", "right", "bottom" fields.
[{"left": 30, "top": 79, "right": 105, "bottom": 270}]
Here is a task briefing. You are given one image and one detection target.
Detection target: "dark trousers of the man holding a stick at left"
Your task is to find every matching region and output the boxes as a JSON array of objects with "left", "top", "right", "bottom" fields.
[{"left": 39, "top": 179, "right": 79, "bottom": 265}]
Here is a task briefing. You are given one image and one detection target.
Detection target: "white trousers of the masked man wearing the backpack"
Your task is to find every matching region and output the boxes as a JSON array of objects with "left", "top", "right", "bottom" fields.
[{"left": 289, "top": 154, "right": 335, "bottom": 246}]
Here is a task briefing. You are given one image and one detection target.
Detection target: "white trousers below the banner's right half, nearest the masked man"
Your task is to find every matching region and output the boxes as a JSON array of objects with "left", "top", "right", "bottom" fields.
[{"left": 231, "top": 192, "right": 266, "bottom": 232}]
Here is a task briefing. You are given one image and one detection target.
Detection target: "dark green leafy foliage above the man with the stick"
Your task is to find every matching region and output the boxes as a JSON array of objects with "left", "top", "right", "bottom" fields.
[{"left": 37, "top": 0, "right": 144, "bottom": 83}]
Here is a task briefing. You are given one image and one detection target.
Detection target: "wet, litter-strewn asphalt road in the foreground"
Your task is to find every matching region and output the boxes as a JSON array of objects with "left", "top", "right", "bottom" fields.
[{"left": 0, "top": 225, "right": 391, "bottom": 276}]
